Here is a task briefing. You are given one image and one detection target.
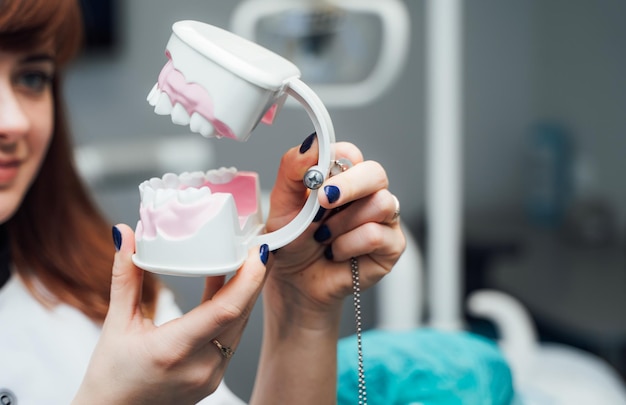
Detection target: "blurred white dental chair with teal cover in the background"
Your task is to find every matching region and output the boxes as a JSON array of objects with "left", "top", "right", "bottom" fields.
[{"left": 338, "top": 224, "right": 626, "bottom": 405}]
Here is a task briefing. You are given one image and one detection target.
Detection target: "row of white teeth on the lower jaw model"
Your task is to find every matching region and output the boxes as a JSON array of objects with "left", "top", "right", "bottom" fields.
[{"left": 139, "top": 167, "right": 237, "bottom": 208}]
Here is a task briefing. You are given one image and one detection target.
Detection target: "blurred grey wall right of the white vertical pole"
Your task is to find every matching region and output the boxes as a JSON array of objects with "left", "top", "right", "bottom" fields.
[{"left": 464, "top": 0, "right": 626, "bottom": 229}]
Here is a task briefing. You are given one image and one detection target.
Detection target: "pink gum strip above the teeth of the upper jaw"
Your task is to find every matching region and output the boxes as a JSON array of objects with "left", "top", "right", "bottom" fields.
[{"left": 158, "top": 52, "right": 236, "bottom": 139}]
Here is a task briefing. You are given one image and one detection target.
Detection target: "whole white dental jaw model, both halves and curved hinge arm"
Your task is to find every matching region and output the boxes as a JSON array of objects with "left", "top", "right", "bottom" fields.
[{"left": 133, "top": 21, "right": 335, "bottom": 276}]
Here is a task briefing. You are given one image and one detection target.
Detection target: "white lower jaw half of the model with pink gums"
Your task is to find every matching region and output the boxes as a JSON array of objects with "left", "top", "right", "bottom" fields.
[{"left": 134, "top": 168, "right": 264, "bottom": 276}]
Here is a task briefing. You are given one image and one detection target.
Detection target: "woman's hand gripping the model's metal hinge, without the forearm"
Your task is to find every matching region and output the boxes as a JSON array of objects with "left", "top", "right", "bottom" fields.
[{"left": 264, "top": 136, "right": 406, "bottom": 327}]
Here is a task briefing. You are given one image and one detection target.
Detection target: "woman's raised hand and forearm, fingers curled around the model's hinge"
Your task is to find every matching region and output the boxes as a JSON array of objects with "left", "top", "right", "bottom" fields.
[{"left": 251, "top": 137, "right": 406, "bottom": 405}]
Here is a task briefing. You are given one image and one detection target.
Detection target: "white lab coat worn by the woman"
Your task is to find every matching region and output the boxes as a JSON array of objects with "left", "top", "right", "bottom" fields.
[{"left": 0, "top": 275, "right": 243, "bottom": 405}]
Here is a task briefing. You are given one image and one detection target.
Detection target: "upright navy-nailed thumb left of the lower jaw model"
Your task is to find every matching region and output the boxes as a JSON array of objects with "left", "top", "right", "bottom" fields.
[{"left": 107, "top": 224, "right": 143, "bottom": 323}]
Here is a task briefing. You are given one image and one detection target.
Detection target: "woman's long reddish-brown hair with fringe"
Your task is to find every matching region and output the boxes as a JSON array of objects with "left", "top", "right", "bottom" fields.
[{"left": 0, "top": 0, "right": 158, "bottom": 321}]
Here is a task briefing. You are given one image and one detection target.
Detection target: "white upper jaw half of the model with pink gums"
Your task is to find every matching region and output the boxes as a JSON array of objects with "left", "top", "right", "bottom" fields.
[{"left": 148, "top": 21, "right": 300, "bottom": 141}]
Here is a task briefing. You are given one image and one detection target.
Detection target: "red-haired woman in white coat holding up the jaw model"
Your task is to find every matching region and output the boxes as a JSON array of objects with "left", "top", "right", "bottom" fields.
[{"left": 0, "top": 0, "right": 405, "bottom": 404}]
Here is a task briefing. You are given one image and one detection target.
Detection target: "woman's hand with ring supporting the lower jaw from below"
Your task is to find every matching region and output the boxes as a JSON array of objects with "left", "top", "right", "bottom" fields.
[{"left": 74, "top": 225, "right": 268, "bottom": 404}]
